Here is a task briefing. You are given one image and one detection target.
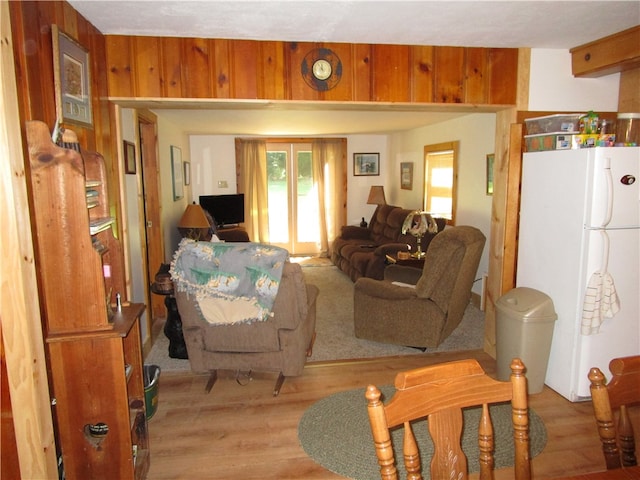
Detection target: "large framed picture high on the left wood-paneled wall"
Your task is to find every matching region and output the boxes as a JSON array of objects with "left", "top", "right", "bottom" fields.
[{"left": 51, "top": 25, "right": 93, "bottom": 127}]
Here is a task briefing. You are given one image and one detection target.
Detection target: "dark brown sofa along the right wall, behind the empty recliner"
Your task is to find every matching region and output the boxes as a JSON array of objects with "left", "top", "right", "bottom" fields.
[{"left": 331, "top": 205, "right": 446, "bottom": 282}]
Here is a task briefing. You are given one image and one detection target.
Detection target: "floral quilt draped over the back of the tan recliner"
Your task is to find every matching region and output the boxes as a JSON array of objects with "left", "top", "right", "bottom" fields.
[{"left": 170, "top": 238, "right": 289, "bottom": 325}]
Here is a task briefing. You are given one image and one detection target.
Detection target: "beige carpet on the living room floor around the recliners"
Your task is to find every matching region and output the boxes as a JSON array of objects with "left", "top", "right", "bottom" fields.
[{"left": 145, "top": 259, "right": 484, "bottom": 372}]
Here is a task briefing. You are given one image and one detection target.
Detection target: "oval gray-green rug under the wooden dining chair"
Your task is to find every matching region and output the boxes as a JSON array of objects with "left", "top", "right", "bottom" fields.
[{"left": 298, "top": 385, "right": 547, "bottom": 480}]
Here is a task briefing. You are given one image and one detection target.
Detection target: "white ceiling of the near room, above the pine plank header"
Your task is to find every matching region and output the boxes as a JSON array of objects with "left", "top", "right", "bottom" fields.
[{"left": 68, "top": 0, "right": 640, "bottom": 49}]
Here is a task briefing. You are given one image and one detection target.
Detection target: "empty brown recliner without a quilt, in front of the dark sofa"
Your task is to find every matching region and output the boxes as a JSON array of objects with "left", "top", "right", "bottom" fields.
[{"left": 353, "top": 226, "right": 486, "bottom": 348}]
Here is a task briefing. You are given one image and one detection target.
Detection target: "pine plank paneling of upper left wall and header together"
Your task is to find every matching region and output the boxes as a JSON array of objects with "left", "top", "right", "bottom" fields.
[{"left": 9, "top": 1, "right": 518, "bottom": 208}]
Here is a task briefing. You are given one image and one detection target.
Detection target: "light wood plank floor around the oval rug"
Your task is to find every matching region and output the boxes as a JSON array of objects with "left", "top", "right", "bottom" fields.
[{"left": 148, "top": 351, "right": 640, "bottom": 480}]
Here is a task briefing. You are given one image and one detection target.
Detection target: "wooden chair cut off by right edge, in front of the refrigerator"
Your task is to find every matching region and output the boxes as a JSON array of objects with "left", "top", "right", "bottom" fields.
[{"left": 589, "top": 356, "right": 640, "bottom": 470}]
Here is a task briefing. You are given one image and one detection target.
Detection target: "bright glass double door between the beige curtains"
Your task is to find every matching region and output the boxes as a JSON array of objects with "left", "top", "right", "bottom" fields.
[{"left": 267, "top": 142, "right": 320, "bottom": 255}]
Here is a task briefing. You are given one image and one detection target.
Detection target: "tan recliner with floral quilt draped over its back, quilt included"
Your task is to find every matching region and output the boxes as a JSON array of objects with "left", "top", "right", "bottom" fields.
[{"left": 171, "top": 240, "right": 318, "bottom": 396}]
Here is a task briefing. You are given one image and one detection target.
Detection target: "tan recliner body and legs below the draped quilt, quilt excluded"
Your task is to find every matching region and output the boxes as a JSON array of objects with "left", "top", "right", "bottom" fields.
[{"left": 174, "top": 244, "right": 318, "bottom": 396}]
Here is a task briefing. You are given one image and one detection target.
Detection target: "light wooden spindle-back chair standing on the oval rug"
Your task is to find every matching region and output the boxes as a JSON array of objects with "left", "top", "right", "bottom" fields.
[{"left": 365, "top": 359, "right": 531, "bottom": 480}]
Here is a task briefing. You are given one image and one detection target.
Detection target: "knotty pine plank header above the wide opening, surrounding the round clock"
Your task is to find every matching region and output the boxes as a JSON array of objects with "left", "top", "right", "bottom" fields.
[{"left": 105, "top": 35, "right": 518, "bottom": 105}]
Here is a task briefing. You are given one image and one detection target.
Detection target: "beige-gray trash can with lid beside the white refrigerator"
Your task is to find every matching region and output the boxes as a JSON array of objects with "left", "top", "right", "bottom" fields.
[{"left": 496, "top": 287, "right": 558, "bottom": 394}]
